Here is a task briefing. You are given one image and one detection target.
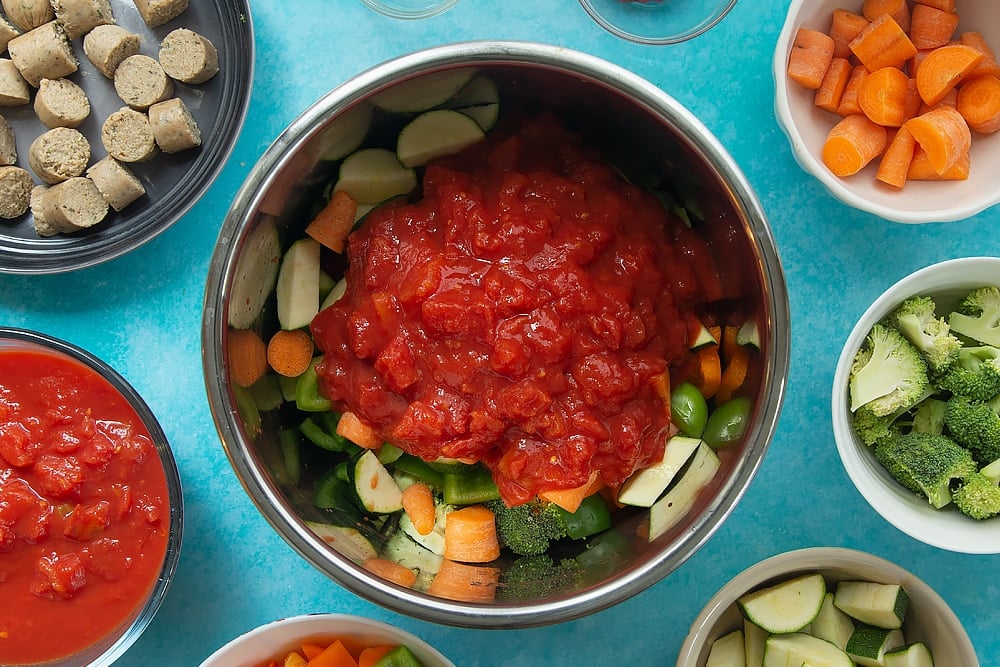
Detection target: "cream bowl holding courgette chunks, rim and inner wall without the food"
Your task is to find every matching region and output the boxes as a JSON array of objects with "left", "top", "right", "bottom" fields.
[{"left": 677, "top": 547, "right": 979, "bottom": 667}]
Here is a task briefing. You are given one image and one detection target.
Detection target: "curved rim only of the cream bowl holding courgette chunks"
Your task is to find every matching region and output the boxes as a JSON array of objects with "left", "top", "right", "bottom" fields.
[{"left": 677, "top": 547, "right": 979, "bottom": 667}]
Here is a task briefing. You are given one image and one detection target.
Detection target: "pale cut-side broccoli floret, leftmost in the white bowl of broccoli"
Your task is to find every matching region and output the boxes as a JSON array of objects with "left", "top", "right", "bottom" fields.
[{"left": 849, "top": 324, "right": 929, "bottom": 417}]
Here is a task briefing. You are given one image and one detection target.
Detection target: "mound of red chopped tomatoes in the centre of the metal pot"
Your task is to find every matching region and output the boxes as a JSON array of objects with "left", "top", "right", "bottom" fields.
[{"left": 312, "top": 115, "right": 718, "bottom": 504}]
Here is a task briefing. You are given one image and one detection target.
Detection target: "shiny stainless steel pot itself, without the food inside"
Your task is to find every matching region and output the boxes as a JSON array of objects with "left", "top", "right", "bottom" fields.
[{"left": 202, "top": 42, "right": 790, "bottom": 628}]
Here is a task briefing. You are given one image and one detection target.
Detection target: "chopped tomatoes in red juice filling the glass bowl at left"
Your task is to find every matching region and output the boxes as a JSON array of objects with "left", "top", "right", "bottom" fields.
[{"left": 0, "top": 350, "right": 170, "bottom": 665}]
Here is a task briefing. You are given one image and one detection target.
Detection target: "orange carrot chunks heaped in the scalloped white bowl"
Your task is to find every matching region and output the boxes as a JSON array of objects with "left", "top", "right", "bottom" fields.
[{"left": 786, "top": 0, "right": 1000, "bottom": 189}]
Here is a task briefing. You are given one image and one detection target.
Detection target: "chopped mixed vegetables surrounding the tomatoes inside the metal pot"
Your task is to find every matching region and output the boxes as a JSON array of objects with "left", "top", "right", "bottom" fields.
[{"left": 228, "top": 69, "right": 761, "bottom": 604}]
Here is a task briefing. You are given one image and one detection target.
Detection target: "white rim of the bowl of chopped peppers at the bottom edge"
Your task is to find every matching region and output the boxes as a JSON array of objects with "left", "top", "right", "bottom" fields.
[{"left": 201, "top": 612, "right": 455, "bottom": 667}]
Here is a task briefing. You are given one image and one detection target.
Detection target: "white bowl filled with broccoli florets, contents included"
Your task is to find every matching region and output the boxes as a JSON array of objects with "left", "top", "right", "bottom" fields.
[{"left": 832, "top": 257, "right": 1000, "bottom": 554}]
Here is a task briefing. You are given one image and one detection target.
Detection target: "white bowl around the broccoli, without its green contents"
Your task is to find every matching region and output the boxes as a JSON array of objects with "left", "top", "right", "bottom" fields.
[{"left": 833, "top": 257, "right": 1000, "bottom": 554}]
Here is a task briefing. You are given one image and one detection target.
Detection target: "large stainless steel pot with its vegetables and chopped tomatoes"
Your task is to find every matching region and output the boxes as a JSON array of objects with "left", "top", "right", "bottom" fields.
[{"left": 203, "top": 42, "right": 789, "bottom": 628}]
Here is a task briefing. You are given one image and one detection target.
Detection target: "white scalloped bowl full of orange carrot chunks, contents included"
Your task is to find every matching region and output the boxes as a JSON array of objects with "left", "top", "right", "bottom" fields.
[{"left": 773, "top": 0, "right": 1000, "bottom": 223}]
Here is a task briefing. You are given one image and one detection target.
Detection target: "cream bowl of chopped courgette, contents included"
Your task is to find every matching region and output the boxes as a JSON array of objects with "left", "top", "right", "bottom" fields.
[{"left": 677, "top": 547, "right": 979, "bottom": 667}]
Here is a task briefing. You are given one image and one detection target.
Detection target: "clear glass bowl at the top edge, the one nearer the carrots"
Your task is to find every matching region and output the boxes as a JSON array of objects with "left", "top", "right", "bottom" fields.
[{"left": 580, "top": 0, "right": 737, "bottom": 45}]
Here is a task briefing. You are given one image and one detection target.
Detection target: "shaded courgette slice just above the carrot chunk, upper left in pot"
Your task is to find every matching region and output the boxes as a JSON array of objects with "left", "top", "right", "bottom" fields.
[{"left": 333, "top": 148, "right": 417, "bottom": 205}]
